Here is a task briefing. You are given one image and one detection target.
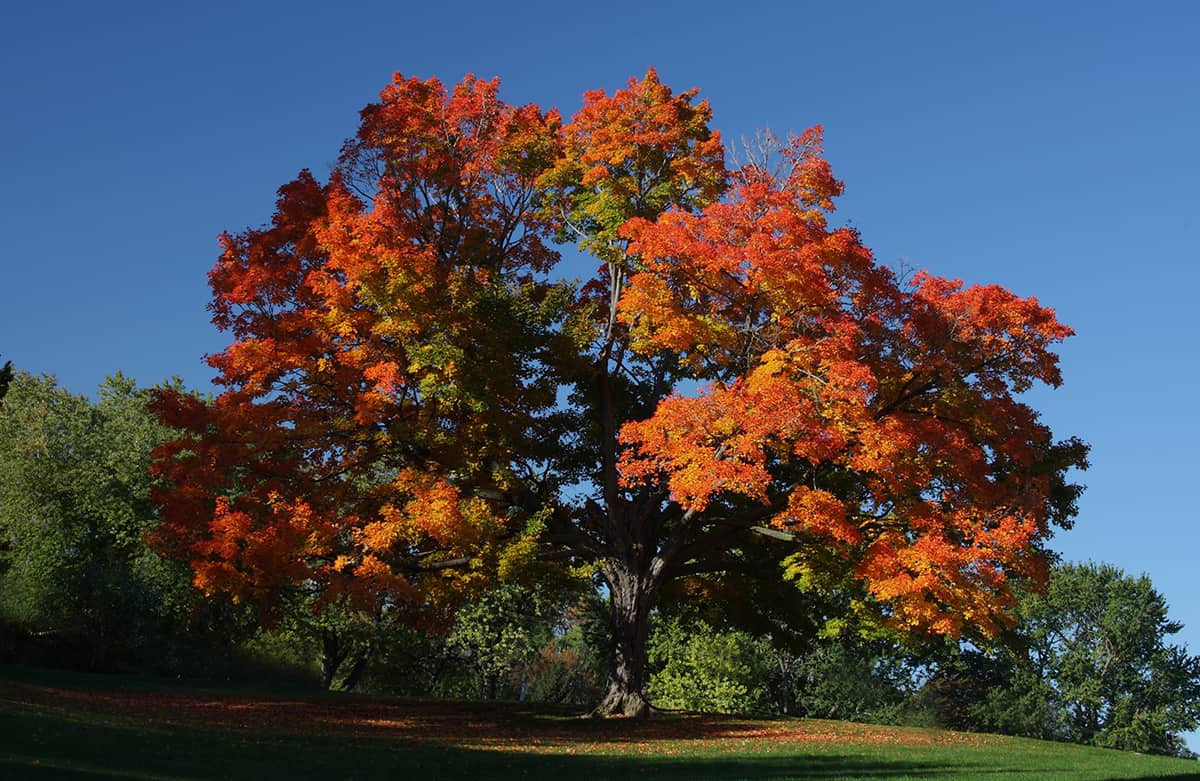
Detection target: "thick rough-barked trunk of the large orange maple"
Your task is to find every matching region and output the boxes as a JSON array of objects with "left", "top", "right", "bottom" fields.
[{"left": 592, "top": 561, "right": 659, "bottom": 717}]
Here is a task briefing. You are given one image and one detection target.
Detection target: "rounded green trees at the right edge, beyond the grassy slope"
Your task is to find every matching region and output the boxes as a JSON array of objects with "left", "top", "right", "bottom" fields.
[{"left": 924, "top": 563, "right": 1200, "bottom": 756}]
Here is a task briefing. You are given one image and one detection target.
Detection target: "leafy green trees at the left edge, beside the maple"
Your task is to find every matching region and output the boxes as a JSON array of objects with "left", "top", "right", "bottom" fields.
[{"left": 0, "top": 372, "right": 247, "bottom": 668}]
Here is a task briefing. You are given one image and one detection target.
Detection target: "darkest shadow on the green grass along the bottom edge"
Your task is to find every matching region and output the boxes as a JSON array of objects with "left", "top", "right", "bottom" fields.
[{"left": 0, "top": 707, "right": 953, "bottom": 781}]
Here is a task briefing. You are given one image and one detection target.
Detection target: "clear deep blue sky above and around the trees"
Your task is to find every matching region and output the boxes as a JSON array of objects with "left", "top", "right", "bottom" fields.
[{"left": 0, "top": 0, "right": 1200, "bottom": 743}]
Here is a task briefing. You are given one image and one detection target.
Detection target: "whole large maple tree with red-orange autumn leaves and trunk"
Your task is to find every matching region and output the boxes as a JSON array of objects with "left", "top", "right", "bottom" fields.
[{"left": 155, "top": 70, "right": 1086, "bottom": 714}]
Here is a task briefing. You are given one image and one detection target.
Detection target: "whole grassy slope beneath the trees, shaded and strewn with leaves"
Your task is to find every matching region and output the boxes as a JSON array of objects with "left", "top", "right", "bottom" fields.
[{"left": 0, "top": 667, "right": 1200, "bottom": 781}]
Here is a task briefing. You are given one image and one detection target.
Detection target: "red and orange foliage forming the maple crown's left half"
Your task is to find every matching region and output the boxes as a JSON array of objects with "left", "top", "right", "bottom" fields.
[{"left": 154, "top": 74, "right": 558, "bottom": 623}]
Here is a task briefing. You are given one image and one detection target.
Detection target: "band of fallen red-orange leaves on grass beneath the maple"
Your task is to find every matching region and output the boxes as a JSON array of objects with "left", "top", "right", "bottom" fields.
[{"left": 0, "top": 675, "right": 950, "bottom": 749}]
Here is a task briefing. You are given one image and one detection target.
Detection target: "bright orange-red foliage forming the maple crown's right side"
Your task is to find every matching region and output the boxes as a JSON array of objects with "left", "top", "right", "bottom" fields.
[{"left": 619, "top": 128, "right": 1084, "bottom": 635}]
